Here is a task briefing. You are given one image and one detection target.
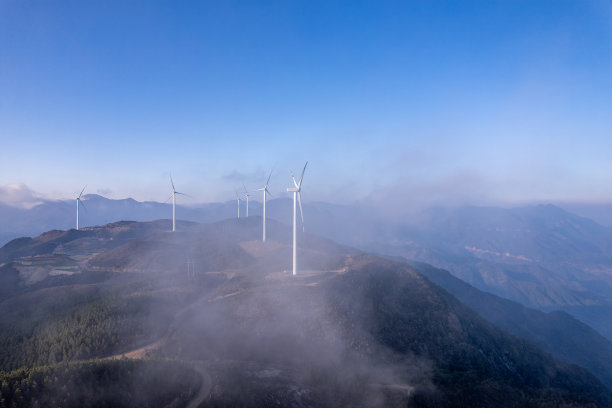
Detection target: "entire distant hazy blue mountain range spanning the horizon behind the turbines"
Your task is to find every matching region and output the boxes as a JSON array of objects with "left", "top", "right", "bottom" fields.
[{"left": 0, "top": 194, "right": 612, "bottom": 339}]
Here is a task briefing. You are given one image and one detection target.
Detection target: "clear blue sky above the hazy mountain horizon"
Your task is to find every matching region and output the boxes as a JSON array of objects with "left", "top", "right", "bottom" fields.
[{"left": 0, "top": 0, "right": 612, "bottom": 209}]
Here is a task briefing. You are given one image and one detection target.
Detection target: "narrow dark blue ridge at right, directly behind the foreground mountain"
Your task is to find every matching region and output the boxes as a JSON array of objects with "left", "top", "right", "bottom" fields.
[{"left": 409, "top": 262, "right": 612, "bottom": 387}]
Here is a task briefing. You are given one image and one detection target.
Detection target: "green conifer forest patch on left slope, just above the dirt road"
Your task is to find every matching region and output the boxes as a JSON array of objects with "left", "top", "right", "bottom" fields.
[{"left": 0, "top": 286, "right": 167, "bottom": 371}]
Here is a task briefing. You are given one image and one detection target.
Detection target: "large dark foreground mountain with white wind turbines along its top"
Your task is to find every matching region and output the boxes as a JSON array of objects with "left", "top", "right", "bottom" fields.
[{"left": 0, "top": 222, "right": 612, "bottom": 407}]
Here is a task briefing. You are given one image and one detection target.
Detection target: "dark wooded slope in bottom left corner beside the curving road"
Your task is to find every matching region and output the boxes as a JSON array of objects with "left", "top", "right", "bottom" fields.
[{"left": 0, "top": 359, "right": 201, "bottom": 408}]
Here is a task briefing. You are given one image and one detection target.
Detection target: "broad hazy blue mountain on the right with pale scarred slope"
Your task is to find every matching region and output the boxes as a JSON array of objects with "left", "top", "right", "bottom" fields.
[{"left": 354, "top": 205, "right": 612, "bottom": 339}]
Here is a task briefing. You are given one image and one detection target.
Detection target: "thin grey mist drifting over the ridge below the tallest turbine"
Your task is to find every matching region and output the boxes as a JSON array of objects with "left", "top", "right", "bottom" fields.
[{"left": 83, "top": 222, "right": 436, "bottom": 407}]
